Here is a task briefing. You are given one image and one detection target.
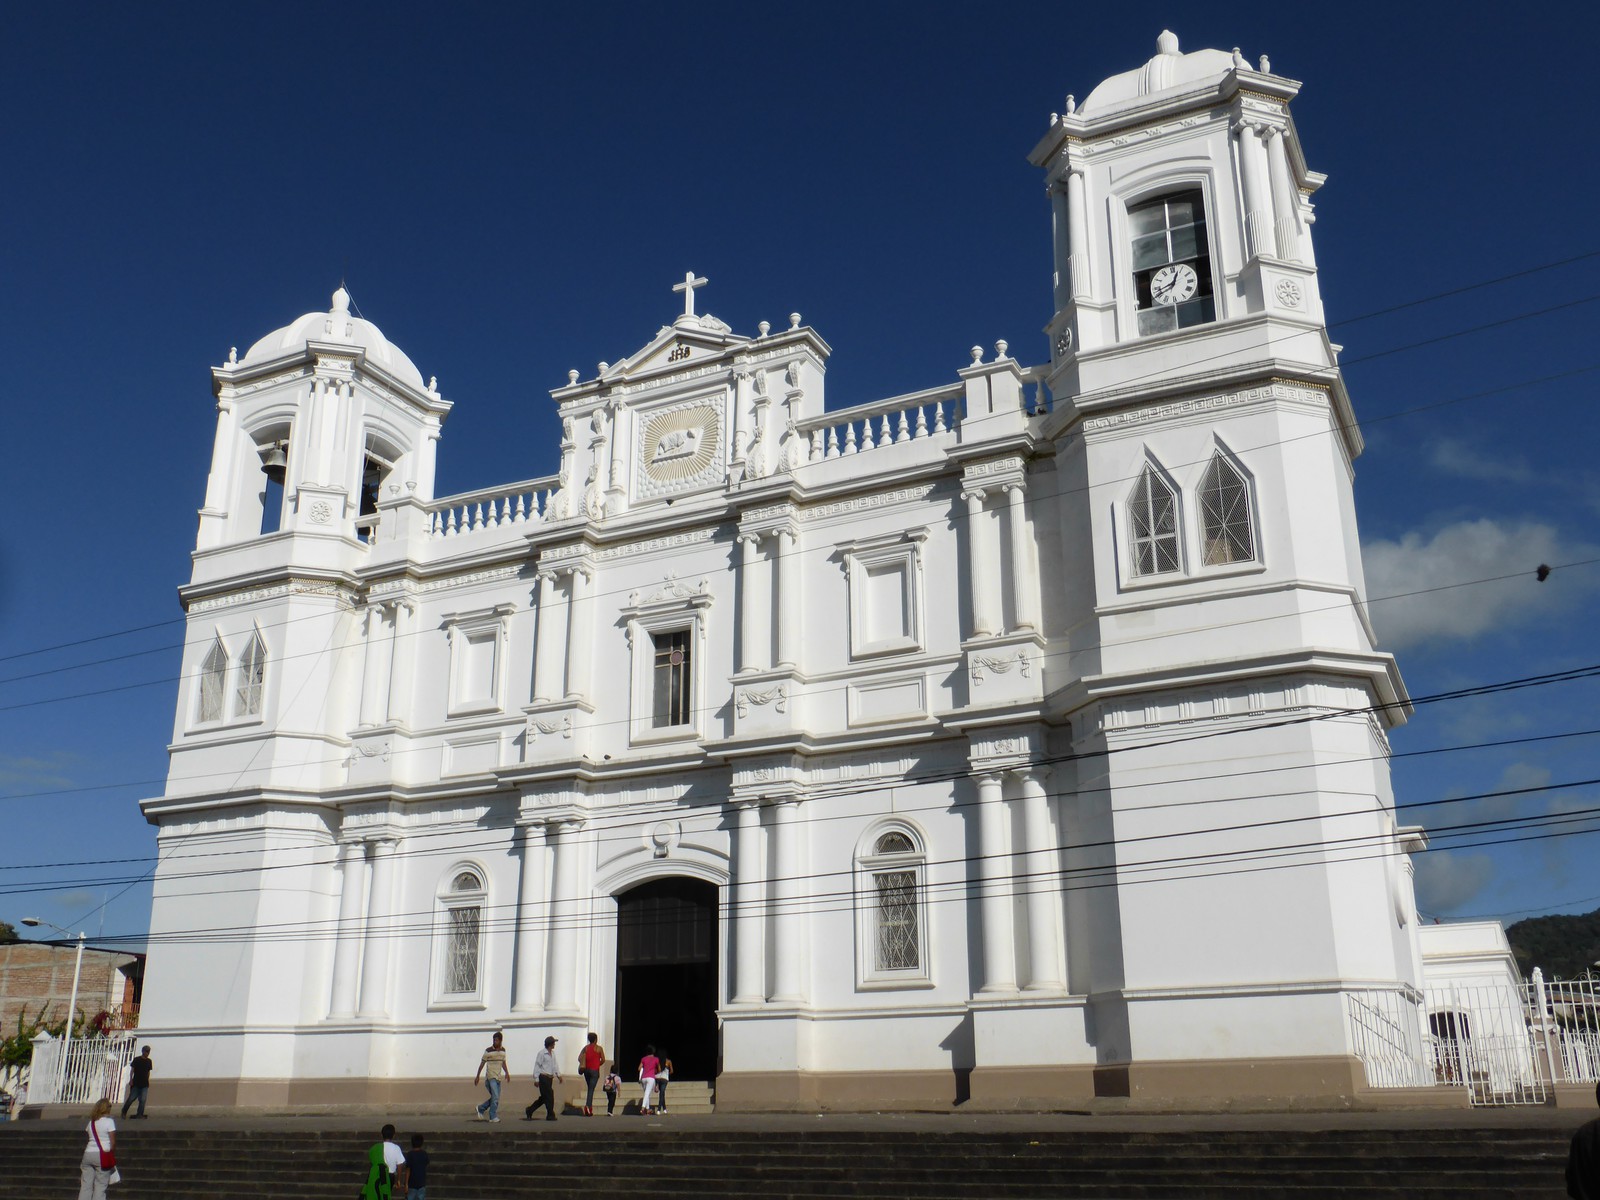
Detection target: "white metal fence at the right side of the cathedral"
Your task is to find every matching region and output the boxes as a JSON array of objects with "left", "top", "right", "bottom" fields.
[{"left": 1346, "top": 970, "right": 1600, "bottom": 1106}]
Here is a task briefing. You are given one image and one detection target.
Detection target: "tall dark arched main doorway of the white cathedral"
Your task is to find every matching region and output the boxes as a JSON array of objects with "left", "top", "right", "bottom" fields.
[{"left": 616, "top": 877, "right": 717, "bottom": 1082}]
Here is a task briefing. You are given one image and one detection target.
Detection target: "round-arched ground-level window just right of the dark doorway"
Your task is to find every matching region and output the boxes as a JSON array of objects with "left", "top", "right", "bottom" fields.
[{"left": 856, "top": 827, "right": 931, "bottom": 989}]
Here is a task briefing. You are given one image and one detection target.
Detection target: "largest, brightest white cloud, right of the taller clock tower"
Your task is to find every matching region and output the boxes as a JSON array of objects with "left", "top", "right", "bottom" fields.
[{"left": 1362, "top": 517, "right": 1600, "bottom": 650}]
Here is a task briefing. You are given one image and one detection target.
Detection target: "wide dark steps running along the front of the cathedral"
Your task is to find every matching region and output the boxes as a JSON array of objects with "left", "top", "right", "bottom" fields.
[{"left": 0, "top": 1126, "right": 1568, "bottom": 1200}]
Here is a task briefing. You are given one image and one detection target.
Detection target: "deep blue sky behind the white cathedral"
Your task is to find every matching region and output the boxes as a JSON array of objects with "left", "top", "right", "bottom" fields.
[{"left": 0, "top": 3, "right": 1600, "bottom": 953}]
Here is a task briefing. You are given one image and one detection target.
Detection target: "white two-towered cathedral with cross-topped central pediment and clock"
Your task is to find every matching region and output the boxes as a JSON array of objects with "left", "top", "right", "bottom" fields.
[{"left": 142, "top": 34, "right": 1422, "bottom": 1109}]
